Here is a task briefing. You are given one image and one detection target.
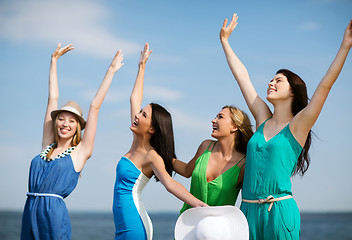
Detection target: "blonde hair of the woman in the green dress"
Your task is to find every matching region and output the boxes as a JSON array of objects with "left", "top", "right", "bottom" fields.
[{"left": 222, "top": 105, "right": 253, "bottom": 154}]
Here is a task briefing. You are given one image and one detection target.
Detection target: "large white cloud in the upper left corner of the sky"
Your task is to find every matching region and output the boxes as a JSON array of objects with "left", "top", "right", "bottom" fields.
[{"left": 0, "top": 0, "right": 140, "bottom": 57}]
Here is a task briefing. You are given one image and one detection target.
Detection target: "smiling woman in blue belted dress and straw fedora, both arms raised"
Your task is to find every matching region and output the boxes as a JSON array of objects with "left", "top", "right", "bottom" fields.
[{"left": 21, "top": 44, "right": 123, "bottom": 240}]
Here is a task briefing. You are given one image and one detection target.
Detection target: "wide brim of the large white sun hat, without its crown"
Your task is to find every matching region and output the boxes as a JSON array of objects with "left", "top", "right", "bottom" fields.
[{"left": 175, "top": 206, "right": 249, "bottom": 240}]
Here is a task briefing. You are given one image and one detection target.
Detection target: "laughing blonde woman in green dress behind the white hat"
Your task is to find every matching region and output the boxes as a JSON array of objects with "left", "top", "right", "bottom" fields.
[{"left": 173, "top": 106, "right": 253, "bottom": 213}]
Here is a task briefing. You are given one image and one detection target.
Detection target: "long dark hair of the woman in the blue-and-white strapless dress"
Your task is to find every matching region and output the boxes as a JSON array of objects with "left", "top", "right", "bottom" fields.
[{"left": 150, "top": 103, "right": 176, "bottom": 181}]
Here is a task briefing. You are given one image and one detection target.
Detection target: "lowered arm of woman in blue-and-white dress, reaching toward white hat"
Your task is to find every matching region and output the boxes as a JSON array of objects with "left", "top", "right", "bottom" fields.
[{"left": 151, "top": 153, "right": 208, "bottom": 207}]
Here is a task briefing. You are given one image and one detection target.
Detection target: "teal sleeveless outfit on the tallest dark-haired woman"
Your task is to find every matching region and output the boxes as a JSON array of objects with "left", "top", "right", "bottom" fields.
[{"left": 241, "top": 120, "right": 302, "bottom": 240}]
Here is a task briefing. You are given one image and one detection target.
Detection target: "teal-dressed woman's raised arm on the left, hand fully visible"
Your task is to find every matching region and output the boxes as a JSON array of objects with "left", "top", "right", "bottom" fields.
[{"left": 220, "top": 14, "right": 272, "bottom": 127}]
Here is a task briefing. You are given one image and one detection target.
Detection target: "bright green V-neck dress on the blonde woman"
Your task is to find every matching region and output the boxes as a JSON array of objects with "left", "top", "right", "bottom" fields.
[{"left": 180, "top": 141, "right": 244, "bottom": 213}]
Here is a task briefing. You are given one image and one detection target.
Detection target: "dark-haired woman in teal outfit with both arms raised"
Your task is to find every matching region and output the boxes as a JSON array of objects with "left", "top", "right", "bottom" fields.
[{"left": 220, "top": 14, "right": 352, "bottom": 240}]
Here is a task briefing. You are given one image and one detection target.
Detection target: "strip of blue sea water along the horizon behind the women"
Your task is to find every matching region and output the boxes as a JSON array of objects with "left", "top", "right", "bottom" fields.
[{"left": 0, "top": 211, "right": 352, "bottom": 240}]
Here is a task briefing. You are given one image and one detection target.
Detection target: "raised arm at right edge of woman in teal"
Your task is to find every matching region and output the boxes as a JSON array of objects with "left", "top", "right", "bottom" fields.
[{"left": 290, "top": 20, "right": 352, "bottom": 146}]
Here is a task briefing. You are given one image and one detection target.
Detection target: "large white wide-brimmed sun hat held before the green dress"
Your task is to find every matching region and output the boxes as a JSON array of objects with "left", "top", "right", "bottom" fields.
[{"left": 175, "top": 206, "right": 249, "bottom": 240}]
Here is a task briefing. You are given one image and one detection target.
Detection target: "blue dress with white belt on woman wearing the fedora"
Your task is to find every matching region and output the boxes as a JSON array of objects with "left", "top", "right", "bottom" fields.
[{"left": 21, "top": 144, "right": 80, "bottom": 240}]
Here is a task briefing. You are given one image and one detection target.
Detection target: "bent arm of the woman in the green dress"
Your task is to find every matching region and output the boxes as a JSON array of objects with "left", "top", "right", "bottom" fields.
[{"left": 172, "top": 140, "right": 211, "bottom": 178}]
